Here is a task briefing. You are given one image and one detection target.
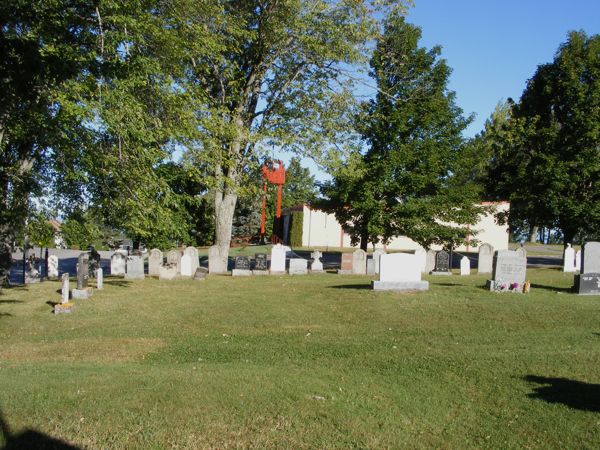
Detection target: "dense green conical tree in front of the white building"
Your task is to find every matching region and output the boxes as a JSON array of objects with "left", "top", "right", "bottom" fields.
[{"left": 324, "top": 15, "right": 483, "bottom": 249}]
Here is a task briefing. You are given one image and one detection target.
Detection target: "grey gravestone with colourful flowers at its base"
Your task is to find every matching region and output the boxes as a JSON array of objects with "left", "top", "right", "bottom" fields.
[{"left": 488, "top": 250, "right": 527, "bottom": 292}]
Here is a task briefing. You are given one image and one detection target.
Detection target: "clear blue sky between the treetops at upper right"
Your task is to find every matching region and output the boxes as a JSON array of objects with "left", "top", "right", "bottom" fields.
[{"left": 407, "top": 0, "right": 600, "bottom": 136}]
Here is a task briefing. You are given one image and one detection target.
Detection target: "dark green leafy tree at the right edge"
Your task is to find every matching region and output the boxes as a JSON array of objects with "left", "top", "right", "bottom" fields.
[{"left": 490, "top": 32, "right": 600, "bottom": 244}]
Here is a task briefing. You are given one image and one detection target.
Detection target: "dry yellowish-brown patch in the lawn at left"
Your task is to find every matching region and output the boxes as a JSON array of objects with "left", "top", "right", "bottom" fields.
[{"left": 0, "top": 337, "right": 165, "bottom": 363}]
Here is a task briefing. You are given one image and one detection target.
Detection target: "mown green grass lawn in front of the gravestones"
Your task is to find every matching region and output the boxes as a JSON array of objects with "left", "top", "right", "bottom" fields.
[{"left": 0, "top": 269, "right": 600, "bottom": 449}]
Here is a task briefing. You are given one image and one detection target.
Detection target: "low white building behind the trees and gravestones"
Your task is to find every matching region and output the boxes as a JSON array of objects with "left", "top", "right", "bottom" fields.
[{"left": 282, "top": 202, "right": 510, "bottom": 252}]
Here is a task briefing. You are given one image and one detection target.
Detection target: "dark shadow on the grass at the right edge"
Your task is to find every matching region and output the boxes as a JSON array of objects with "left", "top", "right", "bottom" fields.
[{"left": 523, "top": 375, "right": 600, "bottom": 412}]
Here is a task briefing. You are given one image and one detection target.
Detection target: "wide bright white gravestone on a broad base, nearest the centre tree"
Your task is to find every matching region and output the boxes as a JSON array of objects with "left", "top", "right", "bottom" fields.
[{"left": 371, "top": 253, "right": 429, "bottom": 291}]
